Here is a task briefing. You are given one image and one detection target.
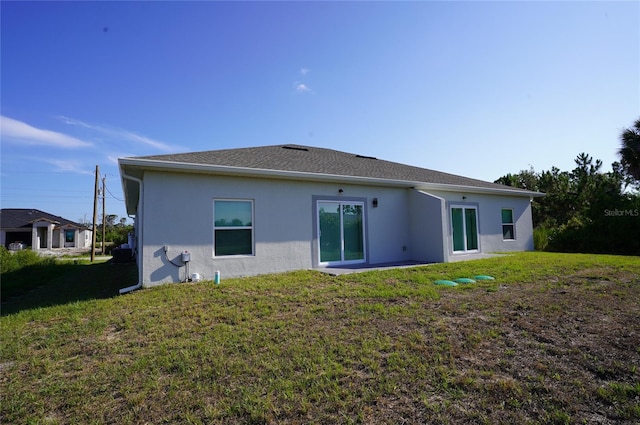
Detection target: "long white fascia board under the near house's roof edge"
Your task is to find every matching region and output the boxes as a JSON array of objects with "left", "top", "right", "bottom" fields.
[{"left": 118, "top": 158, "right": 544, "bottom": 198}]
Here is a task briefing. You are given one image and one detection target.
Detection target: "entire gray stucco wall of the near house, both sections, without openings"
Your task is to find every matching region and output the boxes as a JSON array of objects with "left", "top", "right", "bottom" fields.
[{"left": 136, "top": 171, "right": 533, "bottom": 286}]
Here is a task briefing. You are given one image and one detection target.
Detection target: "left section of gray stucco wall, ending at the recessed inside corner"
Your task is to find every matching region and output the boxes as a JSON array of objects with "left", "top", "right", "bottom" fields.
[{"left": 140, "top": 172, "right": 411, "bottom": 286}]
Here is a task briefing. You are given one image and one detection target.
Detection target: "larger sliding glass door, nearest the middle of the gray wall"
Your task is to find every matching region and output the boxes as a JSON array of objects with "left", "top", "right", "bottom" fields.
[{"left": 318, "top": 201, "right": 365, "bottom": 264}]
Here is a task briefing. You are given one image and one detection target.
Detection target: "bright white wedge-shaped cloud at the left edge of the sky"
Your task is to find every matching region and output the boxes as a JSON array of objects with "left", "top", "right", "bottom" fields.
[{"left": 0, "top": 115, "right": 92, "bottom": 149}]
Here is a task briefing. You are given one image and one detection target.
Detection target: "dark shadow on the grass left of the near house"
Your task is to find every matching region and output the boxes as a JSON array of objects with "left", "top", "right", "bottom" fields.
[{"left": 0, "top": 261, "right": 137, "bottom": 316}]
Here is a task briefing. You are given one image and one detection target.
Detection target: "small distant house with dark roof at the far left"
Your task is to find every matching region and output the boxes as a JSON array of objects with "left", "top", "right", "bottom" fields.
[{"left": 0, "top": 208, "right": 92, "bottom": 250}]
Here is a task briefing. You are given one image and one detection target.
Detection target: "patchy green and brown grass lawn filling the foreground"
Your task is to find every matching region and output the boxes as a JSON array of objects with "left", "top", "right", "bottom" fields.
[{"left": 0, "top": 253, "right": 640, "bottom": 424}]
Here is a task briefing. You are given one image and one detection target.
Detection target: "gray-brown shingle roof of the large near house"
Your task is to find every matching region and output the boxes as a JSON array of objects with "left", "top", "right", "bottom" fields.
[{"left": 135, "top": 145, "right": 534, "bottom": 193}]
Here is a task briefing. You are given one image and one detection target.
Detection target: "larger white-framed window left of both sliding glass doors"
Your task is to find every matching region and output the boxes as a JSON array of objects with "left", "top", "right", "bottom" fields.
[{"left": 213, "top": 199, "right": 253, "bottom": 257}]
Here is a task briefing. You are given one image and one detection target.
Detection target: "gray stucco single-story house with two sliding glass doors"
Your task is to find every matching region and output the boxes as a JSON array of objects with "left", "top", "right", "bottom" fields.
[{"left": 118, "top": 145, "right": 542, "bottom": 287}]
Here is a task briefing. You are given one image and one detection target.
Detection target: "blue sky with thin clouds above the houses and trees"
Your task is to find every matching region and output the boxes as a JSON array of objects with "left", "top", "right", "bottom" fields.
[{"left": 0, "top": 1, "right": 640, "bottom": 220}]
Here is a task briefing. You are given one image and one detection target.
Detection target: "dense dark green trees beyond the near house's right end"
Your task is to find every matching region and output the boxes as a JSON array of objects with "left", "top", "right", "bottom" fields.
[{"left": 496, "top": 153, "right": 640, "bottom": 254}]
